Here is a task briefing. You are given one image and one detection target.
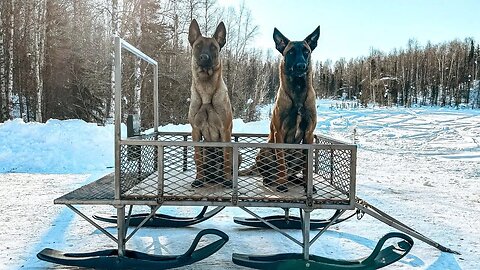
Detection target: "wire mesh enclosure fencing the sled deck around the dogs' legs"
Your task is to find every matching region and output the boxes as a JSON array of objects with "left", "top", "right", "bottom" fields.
[{"left": 121, "top": 133, "right": 356, "bottom": 208}]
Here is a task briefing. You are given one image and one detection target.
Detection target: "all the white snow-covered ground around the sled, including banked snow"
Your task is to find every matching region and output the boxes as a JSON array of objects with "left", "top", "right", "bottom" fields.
[{"left": 0, "top": 100, "right": 480, "bottom": 270}]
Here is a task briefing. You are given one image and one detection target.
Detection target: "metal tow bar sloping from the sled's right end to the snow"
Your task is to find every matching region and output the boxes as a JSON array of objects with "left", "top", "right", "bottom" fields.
[{"left": 355, "top": 197, "right": 460, "bottom": 255}]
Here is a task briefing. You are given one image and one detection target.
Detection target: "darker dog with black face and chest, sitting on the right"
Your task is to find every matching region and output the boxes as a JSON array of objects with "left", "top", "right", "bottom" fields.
[{"left": 256, "top": 26, "right": 320, "bottom": 192}]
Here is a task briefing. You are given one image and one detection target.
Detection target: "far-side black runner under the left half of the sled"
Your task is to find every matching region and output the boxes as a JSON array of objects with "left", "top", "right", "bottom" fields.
[{"left": 93, "top": 206, "right": 225, "bottom": 228}]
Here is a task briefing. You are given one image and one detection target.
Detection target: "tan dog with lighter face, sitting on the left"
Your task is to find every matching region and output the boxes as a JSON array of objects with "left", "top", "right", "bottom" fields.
[{"left": 188, "top": 20, "right": 232, "bottom": 187}]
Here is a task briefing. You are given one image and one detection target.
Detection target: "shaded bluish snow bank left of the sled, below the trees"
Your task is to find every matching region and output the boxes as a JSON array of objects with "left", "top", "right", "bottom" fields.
[{"left": 0, "top": 119, "right": 120, "bottom": 173}]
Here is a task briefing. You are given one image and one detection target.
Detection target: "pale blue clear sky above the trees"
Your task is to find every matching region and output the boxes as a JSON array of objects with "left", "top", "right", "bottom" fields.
[{"left": 218, "top": 0, "right": 480, "bottom": 61}]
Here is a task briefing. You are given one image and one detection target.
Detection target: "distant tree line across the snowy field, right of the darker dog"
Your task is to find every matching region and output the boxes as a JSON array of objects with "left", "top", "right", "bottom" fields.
[{"left": 316, "top": 38, "right": 480, "bottom": 108}]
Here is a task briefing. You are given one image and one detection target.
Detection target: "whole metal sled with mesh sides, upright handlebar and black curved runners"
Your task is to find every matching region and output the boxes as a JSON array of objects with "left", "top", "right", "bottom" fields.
[{"left": 38, "top": 37, "right": 454, "bottom": 269}]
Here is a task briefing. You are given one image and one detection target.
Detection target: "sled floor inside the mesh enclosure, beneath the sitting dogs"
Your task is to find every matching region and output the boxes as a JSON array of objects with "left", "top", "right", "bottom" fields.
[{"left": 123, "top": 171, "right": 348, "bottom": 205}]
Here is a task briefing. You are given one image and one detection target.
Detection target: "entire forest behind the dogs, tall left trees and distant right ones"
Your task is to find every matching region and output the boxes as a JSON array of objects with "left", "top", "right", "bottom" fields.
[{"left": 0, "top": 0, "right": 480, "bottom": 127}]
